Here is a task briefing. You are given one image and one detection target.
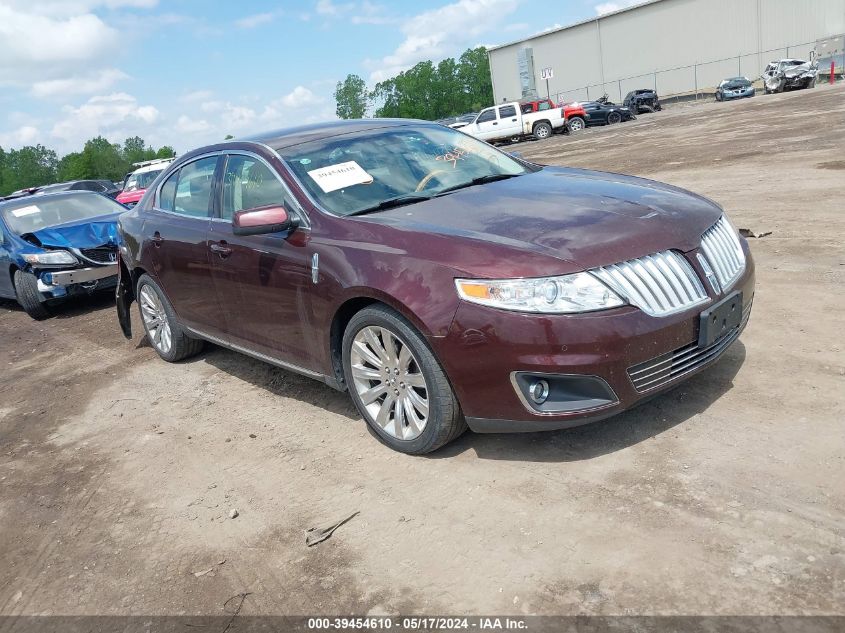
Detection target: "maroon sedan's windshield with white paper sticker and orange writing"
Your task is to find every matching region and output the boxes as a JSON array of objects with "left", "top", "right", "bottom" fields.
[{"left": 279, "top": 125, "right": 531, "bottom": 215}]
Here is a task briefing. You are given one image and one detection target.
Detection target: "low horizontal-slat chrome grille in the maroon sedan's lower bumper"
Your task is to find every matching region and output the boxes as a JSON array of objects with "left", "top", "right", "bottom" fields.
[{"left": 628, "top": 301, "right": 751, "bottom": 392}]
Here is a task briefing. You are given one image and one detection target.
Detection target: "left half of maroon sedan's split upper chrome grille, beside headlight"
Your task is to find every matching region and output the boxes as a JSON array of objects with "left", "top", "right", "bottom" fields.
[{"left": 590, "top": 251, "right": 709, "bottom": 316}]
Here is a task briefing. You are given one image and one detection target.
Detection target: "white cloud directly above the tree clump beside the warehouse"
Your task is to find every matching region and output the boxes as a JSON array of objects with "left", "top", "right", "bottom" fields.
[{"left": 364, "top": 0, "right": 518, "bottom": 82}]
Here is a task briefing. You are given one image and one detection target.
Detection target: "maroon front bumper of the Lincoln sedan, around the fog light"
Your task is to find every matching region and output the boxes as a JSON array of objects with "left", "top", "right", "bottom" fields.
[{"left": 432, "top": 244, "right": 754, "bottom": 432}]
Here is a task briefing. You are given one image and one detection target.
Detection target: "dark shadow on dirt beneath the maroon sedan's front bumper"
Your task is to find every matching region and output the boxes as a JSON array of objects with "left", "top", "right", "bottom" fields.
[{"left": 427, "top": 341, "right": 745, "bottom": 462}]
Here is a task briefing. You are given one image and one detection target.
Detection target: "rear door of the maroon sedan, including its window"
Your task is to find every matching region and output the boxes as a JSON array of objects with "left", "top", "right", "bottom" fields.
[{"left": 142, "top": 156, "right": 224, "bottom": 334}]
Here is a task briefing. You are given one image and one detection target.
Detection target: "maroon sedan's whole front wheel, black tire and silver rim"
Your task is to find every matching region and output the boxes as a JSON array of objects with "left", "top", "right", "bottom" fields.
[{"left": 342, "top": 305, "right": 467, "bottom": 455}]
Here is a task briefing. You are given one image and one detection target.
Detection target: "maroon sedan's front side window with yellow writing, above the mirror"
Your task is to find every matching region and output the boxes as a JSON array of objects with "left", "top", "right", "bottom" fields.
[{"left": 222, "top": 154, "right": 290, "bottom": 220}]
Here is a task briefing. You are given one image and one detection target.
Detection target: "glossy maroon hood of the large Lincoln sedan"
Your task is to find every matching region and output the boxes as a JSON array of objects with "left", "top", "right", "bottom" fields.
[{"left": 372, "top": 167, "right": 722, "bottom": 276}]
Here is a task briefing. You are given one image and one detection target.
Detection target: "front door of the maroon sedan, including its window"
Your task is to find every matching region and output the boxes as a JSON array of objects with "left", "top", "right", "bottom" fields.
[{"left": 208, "top": 153, "right": 316, "bottom": 369}]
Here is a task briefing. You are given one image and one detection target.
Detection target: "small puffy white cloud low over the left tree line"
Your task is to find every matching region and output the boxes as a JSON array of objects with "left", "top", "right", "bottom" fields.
[{"left": 52, "top": 92, "right": 159, "bottom": 145}]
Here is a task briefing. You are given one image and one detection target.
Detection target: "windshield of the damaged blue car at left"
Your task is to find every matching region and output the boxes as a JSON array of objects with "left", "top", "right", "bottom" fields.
[{"left": 0, "top": 193, "right": 126, "bottom": 235}]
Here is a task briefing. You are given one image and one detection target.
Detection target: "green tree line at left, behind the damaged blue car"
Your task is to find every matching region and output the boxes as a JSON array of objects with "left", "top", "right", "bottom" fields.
[{"left": 0, "top": 136, "right": 176, "bottom": 196}]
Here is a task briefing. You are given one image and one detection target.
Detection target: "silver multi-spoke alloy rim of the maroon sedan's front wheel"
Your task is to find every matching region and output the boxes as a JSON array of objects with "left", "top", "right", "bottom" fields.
[{"left": 350, "top": 326, "right": 429, "bottom": 440}]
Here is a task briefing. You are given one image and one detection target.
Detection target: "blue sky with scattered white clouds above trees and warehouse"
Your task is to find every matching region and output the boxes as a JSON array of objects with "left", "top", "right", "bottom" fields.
[{"left": 0, "top": 0, "right": 632, "bottom": 154}]
